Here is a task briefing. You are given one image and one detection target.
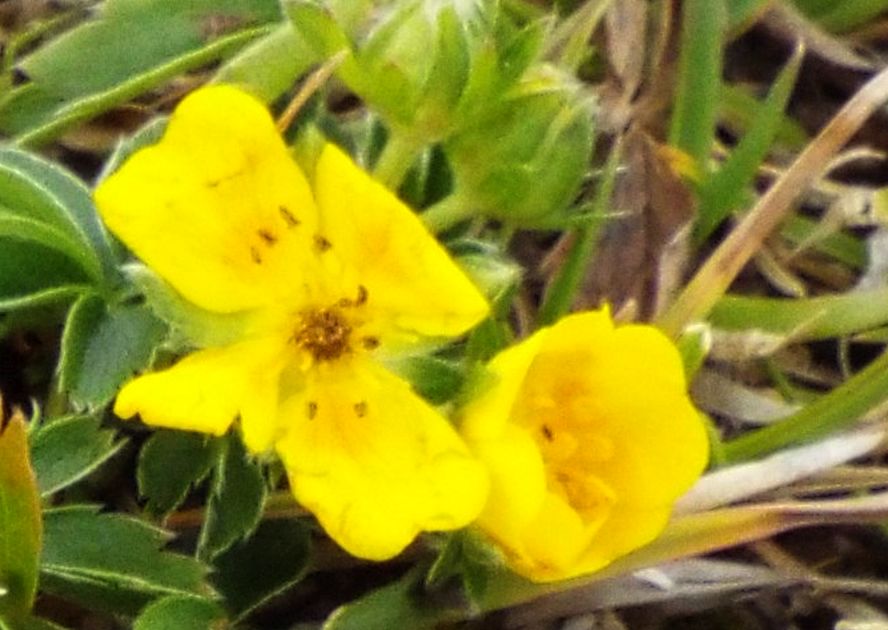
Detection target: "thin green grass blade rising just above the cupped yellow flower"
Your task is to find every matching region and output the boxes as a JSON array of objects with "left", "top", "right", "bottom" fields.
[{"left": 537, "top": 138, "right": 622, "bottom": 326}]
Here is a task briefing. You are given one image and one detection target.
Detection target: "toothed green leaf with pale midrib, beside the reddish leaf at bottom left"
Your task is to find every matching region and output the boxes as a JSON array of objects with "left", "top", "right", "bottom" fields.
[{"left": 40, "top": 505, "right": 206, "bottom": 613}]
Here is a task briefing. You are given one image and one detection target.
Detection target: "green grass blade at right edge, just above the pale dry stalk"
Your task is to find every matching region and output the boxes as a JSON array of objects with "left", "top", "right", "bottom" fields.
[{"left": 724, "top": 351, "right": 888, "bottom": 462}]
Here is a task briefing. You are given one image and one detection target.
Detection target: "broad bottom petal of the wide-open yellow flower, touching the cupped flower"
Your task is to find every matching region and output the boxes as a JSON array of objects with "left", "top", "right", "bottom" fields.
[{"left": 277, "top": 359, "right": 487, "bottom": 560}]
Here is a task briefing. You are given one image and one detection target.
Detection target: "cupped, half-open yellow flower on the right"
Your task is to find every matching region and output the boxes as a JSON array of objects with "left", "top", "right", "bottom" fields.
[{"left": 462, "top": 311, "right": 708, "bottom": 581}]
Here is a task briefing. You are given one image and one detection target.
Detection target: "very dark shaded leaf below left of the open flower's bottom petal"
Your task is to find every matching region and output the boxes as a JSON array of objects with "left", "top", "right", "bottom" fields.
[{"left": 210, "top": 519, "right": 311, "bottom": 618}]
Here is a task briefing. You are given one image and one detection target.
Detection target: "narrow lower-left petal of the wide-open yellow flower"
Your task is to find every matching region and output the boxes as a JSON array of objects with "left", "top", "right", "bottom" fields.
[{"left": 114, "top": 340, "right": 279, "bottom": 450}]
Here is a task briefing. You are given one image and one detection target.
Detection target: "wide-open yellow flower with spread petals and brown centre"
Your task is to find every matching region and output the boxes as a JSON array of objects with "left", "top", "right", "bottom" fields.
[{"left": 95, "top": 86, "right": 488, "bottom": 559}]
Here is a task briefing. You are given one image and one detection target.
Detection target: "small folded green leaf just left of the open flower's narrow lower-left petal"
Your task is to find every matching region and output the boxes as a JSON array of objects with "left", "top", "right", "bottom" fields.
[{"left": 59, "top": 294, "right": 166, "bottom": 408}]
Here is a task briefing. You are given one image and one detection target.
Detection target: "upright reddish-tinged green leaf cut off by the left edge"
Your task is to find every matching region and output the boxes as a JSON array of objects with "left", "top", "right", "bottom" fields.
[{"left": 0, "top": 414, "right": 42, "bottom": 620}]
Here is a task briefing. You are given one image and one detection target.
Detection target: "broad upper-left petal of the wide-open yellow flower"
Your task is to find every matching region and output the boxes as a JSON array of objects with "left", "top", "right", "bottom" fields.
[{"left": 95, "top": 86, "right": 317, "bottom": 312}]
